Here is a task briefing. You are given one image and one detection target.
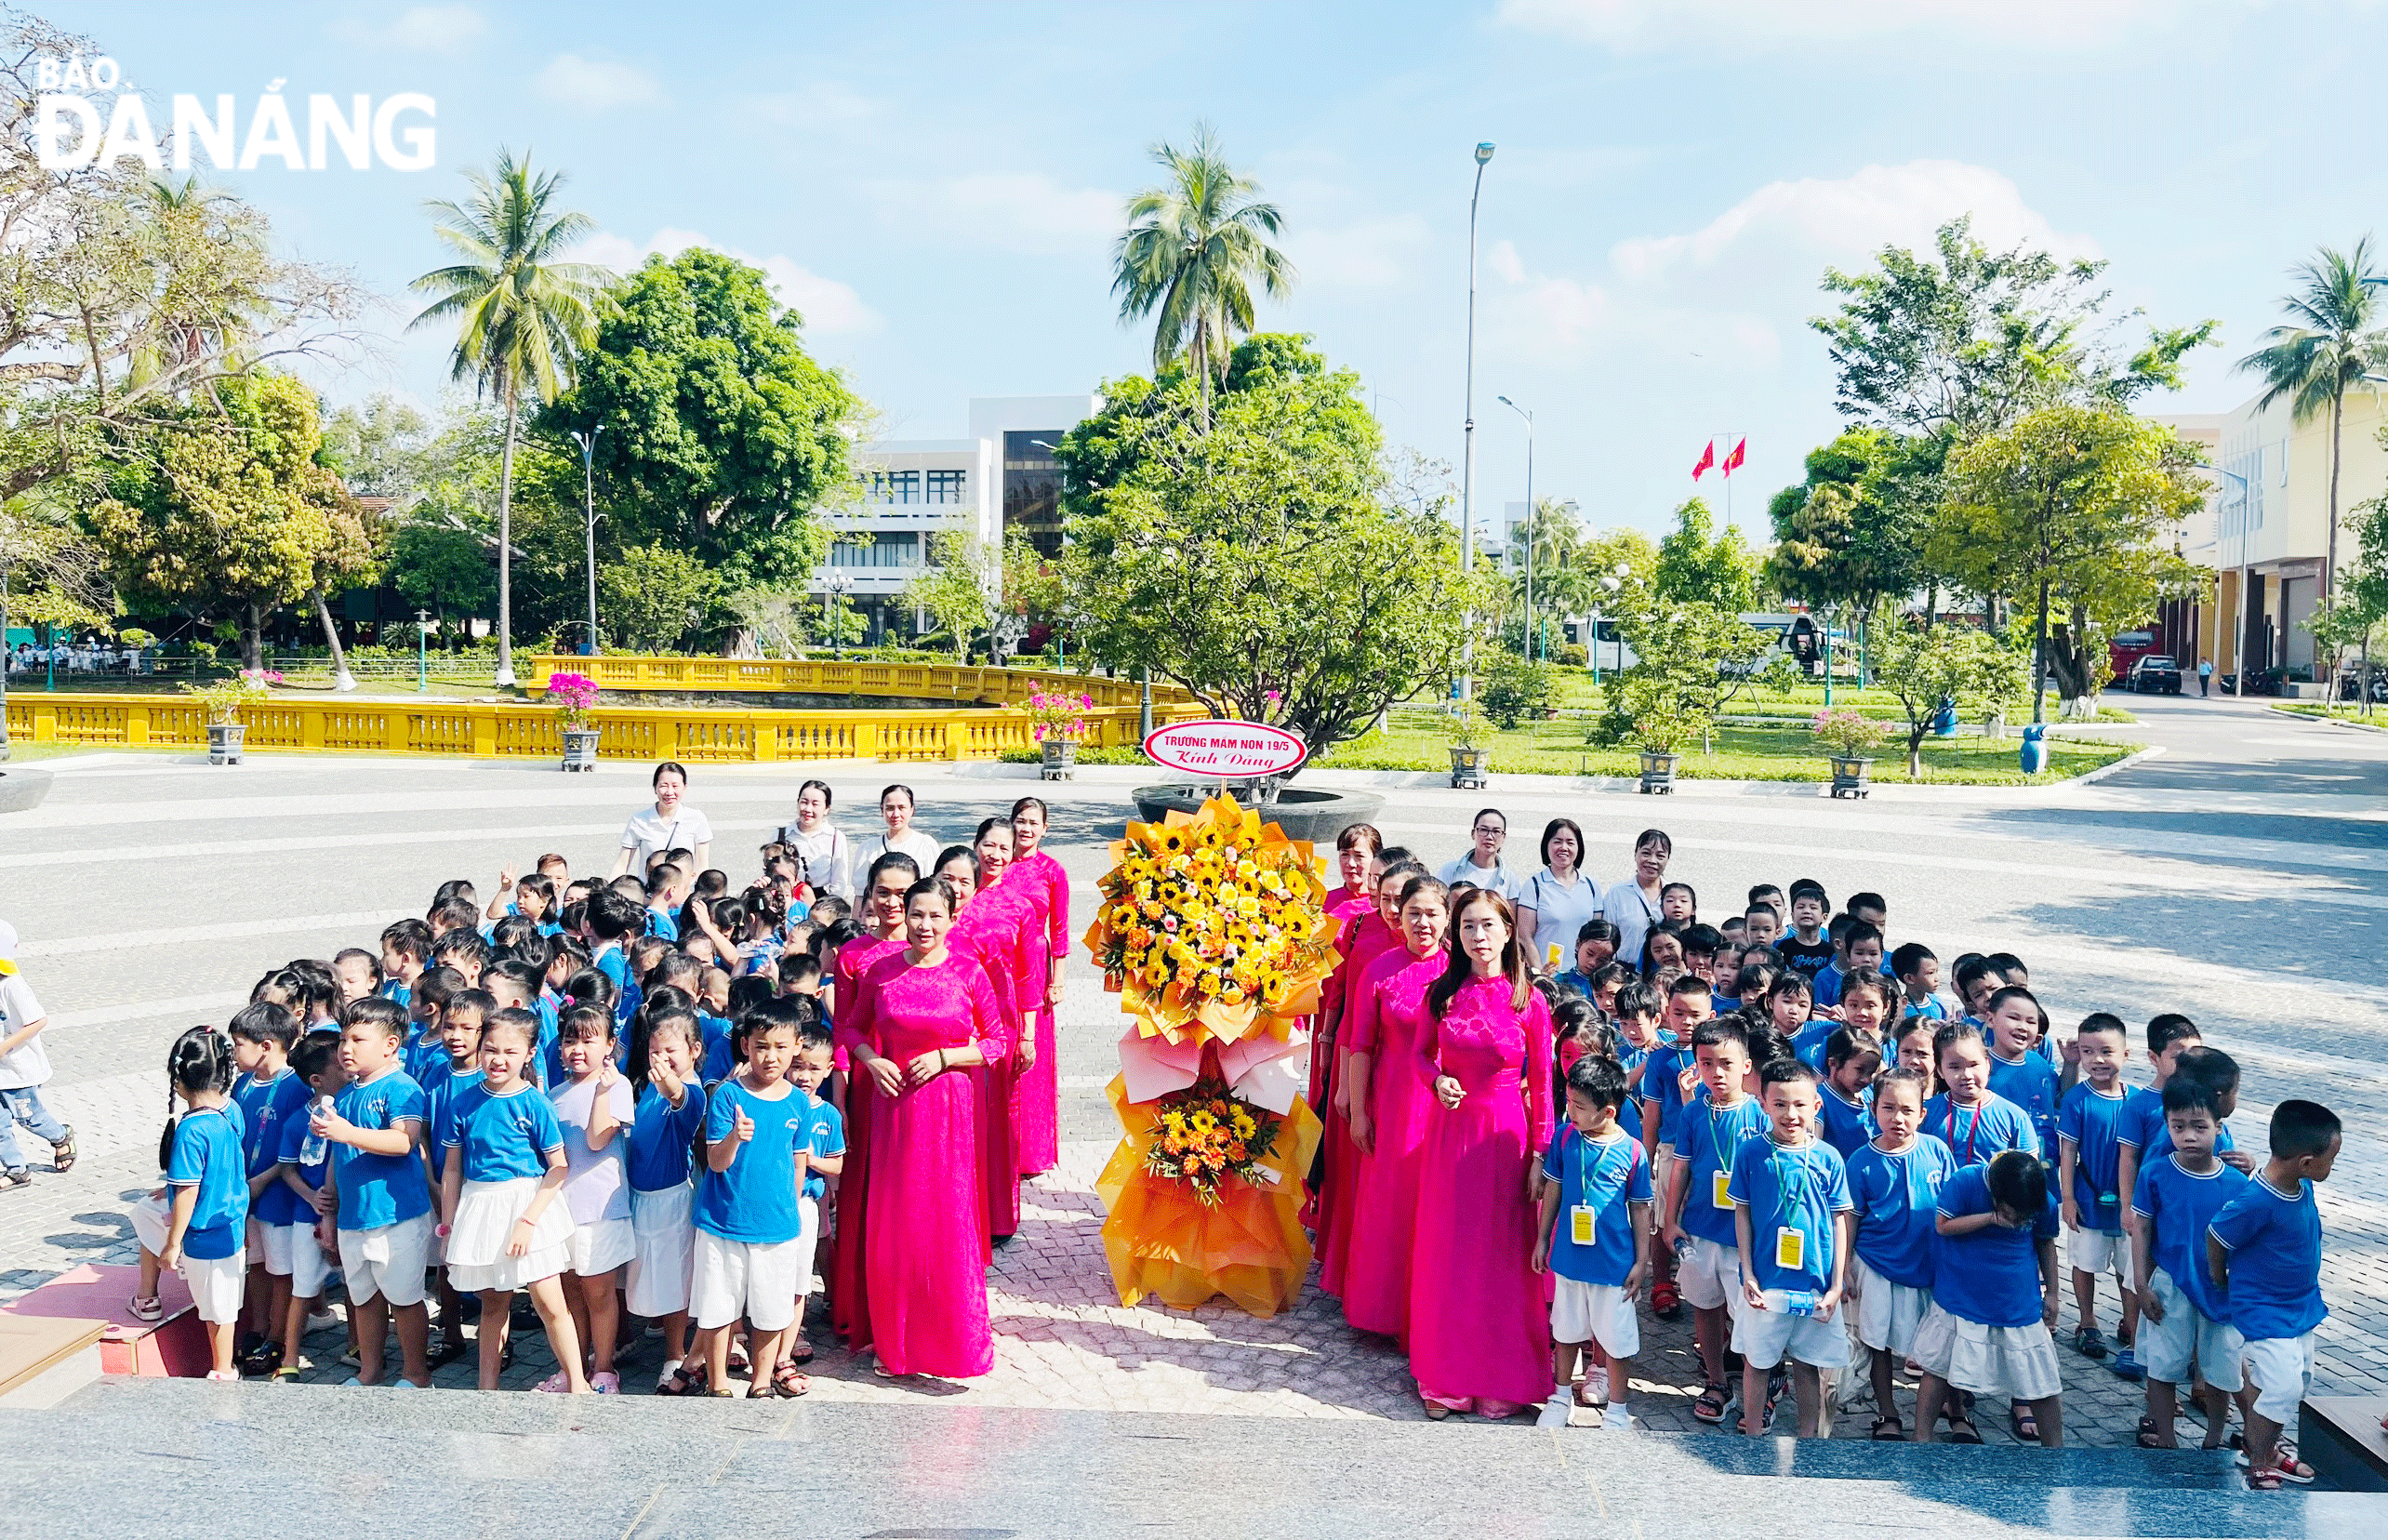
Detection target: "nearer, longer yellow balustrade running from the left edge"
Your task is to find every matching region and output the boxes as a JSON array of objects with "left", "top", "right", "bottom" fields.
[{"left": 7, "top": 692, "right": 1201, "bottom": 764}]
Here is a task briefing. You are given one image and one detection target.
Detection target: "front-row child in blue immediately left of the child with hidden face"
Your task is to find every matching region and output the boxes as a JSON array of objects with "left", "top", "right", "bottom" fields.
[{"left": 1849, "top": 1068, "right": 1956, "bottom": 1442}]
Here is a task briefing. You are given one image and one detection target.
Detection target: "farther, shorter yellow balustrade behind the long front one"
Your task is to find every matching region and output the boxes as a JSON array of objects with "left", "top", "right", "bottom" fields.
[{"left": 516, "top": 654, "right": 1194, "bottom": 707}]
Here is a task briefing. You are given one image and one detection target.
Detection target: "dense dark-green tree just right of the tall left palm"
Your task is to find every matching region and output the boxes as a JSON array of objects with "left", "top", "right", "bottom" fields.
[{"left": 539, "top": 246, "right": 865, "bottom": 625}]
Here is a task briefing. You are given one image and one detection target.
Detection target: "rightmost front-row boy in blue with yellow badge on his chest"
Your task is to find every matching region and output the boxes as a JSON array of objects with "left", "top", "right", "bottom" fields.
[{"left": 1727, "top": 1060, "right": 1858, "bottom": 1438}]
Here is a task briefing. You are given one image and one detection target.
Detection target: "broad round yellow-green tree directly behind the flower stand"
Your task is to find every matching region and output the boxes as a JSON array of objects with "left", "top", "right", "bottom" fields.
[{"left": 1060, "top": 346, "right": 1492, "bottom": 754}]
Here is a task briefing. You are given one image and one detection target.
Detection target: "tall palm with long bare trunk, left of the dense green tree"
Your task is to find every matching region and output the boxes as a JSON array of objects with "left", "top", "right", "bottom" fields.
[{"left": 408, "top": 151, "right": 614, "bottom": 687}]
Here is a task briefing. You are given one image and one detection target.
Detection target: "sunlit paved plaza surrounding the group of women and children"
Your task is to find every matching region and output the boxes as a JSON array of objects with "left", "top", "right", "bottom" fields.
[{"left": 0, "top": 699, "right": 2388, "bottom": 1447}]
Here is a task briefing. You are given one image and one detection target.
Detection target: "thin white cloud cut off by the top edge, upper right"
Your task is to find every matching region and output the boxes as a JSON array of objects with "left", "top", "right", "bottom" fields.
[{"left": 1500, "top": 0, "right": 2225, "bottom": 52}]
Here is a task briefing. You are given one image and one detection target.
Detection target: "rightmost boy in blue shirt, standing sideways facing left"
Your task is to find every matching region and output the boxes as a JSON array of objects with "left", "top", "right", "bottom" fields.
[{"left": 2207, "top": 1101, "right": 2342, "bottom": 1493}]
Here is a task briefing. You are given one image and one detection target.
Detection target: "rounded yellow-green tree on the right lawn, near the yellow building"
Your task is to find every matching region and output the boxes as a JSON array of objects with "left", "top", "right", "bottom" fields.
[{"left": 1927, "top": 405, "right": 2204, "bottom": 721}]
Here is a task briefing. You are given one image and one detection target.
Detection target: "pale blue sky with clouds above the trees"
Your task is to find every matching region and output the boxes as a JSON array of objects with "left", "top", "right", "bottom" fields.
[{"left": 38, "top": 0, "right": 2388, "bottom": 527}]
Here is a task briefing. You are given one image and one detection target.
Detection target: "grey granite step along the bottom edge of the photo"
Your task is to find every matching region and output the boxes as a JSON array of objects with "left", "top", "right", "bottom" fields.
[{"left": 0, "top": 1380, "right": 2388, "bottom": 1540}]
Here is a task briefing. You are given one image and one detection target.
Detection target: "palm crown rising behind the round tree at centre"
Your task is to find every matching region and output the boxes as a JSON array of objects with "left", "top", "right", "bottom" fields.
[{"left": 1110, "top": 125, "right": 1294, "bottom": 425}]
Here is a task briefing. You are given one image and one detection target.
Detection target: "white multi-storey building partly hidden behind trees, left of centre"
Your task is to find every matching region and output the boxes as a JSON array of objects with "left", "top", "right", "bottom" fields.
[{"left": 812, "top": 396, "right": 1101, "bottom": 643}]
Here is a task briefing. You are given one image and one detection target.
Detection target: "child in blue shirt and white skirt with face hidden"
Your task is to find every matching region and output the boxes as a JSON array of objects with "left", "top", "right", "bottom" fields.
[{"left": 1916, "top": 1146, "right": 2065, "bottom": 1449}]
